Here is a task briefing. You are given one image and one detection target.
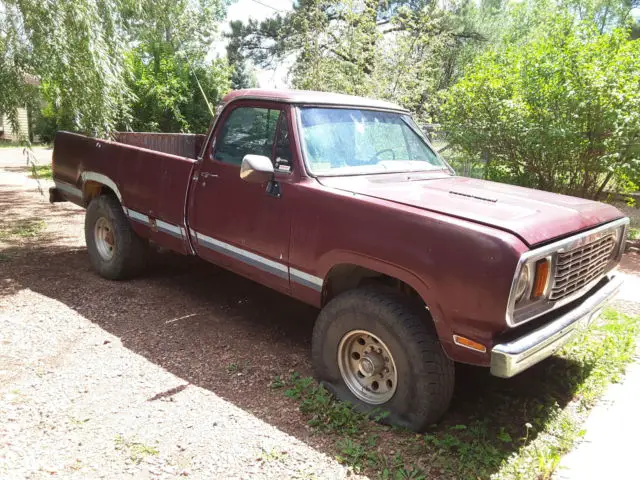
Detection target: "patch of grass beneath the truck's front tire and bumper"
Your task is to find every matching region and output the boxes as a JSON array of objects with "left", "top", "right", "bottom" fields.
[{"left": 272, "top": 310, "right": 640, "bottom": 480}]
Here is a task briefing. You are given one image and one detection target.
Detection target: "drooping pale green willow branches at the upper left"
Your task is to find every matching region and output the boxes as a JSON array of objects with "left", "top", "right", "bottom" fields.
[{"left": 0, "top": 0, "right": 130, "bottom": 134}]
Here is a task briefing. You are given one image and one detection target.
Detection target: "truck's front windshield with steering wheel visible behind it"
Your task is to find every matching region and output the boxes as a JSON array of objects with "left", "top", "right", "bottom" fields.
[{"left": 299, "top": 107, "right": 447, "bottom": 176}]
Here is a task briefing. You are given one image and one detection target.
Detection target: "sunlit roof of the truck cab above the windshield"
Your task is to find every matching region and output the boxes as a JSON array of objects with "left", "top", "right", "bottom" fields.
[{"left": 222, "top": 88, "right": 407, "bottom": 112}]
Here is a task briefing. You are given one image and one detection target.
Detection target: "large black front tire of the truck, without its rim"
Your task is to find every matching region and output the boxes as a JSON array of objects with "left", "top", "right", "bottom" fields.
[{"left": 312, "top": 287, "right": 454, "bottom": 431}]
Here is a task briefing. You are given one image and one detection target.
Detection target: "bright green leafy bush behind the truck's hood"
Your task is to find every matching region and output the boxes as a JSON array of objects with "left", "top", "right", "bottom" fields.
[{"left": 442, "top": 10, "right": 640, "bottom": 198}]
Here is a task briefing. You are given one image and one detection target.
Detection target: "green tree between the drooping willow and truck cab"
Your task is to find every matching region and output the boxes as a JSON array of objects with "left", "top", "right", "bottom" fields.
[{"left": 119, "top": 0, "right": 232, "bottom": 133}]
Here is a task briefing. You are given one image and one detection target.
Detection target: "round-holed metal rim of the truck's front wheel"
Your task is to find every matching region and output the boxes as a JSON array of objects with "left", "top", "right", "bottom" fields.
[{"left": 338, "top": 330, "right": 398, "bottom": 405}]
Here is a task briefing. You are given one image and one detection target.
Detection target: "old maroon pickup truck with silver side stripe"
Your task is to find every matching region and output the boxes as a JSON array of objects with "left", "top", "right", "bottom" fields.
[{"left": 50, "top": 90, "right": 628, "bottom": 430}]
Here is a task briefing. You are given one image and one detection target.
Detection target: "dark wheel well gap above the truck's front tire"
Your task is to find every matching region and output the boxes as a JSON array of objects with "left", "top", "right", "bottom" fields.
[{"left": 322, "top": 264, "right": 425, "bottom": 306}]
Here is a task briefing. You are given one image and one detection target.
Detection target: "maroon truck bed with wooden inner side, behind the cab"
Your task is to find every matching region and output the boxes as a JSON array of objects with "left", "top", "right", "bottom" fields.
[{"left": 53, "top": 132, "right": 200, "bottom": 253}]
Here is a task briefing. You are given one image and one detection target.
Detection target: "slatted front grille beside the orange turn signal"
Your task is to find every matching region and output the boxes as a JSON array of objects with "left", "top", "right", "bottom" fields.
[{"left": 549, "top": 234, "right": 616, "bottom": 300}]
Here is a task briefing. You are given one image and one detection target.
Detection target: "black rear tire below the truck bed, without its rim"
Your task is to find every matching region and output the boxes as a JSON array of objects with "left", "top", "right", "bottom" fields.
[{"left": 84, "top": 195, "right": 149, "bottom": 280}]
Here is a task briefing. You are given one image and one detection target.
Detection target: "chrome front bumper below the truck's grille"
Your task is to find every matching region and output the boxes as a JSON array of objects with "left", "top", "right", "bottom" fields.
[{"left": 491, "top": 276, "right": 622, "bottom": 378}]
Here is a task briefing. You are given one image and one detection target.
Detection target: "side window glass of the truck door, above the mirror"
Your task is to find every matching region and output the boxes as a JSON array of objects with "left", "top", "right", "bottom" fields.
[{"left": 213, "top": 107, "right": 280, "bottom": 165}]
